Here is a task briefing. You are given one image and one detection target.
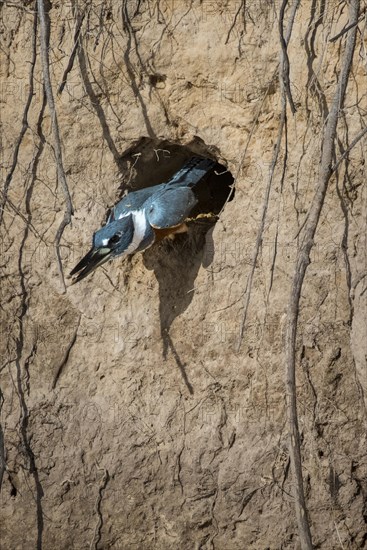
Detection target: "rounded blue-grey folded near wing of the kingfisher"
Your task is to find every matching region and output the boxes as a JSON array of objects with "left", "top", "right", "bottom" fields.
[{"left": 146, "top": 187, "right": 197, "bottom": 229}]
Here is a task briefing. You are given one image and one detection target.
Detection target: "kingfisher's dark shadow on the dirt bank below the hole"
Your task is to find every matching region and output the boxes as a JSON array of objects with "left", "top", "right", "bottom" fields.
[{"left": 143, "top": 223, "right": 213, "bottom": 394}]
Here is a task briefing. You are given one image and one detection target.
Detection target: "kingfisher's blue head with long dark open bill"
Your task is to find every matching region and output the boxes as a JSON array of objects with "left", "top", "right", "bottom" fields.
[{"left": 69, "top": 214, "right": 134, "bottom": 284}]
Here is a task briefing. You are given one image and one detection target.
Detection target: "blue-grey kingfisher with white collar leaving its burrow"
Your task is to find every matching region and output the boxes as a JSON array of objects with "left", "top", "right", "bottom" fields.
[{"left": 69, "top": 157, "right": 217, "bottom": 284}]
